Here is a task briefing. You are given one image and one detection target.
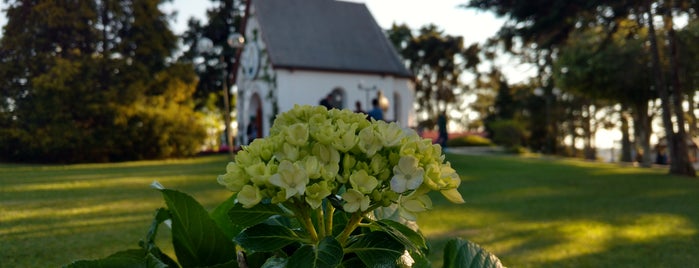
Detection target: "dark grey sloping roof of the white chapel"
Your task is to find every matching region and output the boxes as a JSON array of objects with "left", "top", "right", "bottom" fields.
[{"left": 252, "top": 0, "right": 412, "bottom": 77}]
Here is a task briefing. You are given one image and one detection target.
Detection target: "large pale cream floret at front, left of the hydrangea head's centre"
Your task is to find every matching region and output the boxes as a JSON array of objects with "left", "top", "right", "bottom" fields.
[{"left": 269, "top": 160, "right": 309, "bottom": 199}]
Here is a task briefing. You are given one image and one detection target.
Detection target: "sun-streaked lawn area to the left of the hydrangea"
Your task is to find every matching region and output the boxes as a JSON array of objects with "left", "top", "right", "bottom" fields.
[{"left": 0, "top": 156, "right": 235, "bottom": 267}]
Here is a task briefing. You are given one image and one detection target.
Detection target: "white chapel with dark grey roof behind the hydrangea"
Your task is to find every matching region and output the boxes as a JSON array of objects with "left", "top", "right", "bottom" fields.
[{"left": 236, "top": 0, "right": 416, "bottom": 144}]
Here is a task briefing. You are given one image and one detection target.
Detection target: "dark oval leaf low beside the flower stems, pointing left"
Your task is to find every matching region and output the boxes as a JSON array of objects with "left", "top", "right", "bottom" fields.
[{"left": 235, "top": 224, "right": 305, "bottom": 252}]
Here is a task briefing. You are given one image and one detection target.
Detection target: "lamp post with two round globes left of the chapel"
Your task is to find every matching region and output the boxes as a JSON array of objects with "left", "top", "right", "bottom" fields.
[{"left": 197, "top": 31, "right": 245, "bottom": 158}]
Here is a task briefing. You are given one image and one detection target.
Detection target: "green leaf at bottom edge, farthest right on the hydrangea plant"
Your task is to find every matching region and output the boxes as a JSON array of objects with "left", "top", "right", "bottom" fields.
[{"left": 443, "top": 238, "right": 504, "bottom": 268}]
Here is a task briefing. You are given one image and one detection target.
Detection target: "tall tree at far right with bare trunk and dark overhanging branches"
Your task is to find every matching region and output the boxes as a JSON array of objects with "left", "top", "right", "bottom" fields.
[{"left": 467, "top": 0, "right": 696, "bottom": 176}]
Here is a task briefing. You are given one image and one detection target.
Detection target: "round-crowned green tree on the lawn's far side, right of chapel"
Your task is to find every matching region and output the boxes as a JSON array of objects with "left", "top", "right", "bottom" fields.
[{"left": 553, "top": 20, "right": 657, "bottom": 166}]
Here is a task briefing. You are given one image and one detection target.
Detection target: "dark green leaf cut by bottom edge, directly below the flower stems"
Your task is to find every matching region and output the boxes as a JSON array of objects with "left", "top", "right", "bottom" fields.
[{"left": 288, "top": 237, "right": 344, "bottom": 268}]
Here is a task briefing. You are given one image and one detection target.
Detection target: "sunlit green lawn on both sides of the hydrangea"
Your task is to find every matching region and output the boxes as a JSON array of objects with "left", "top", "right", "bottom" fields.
[{"left": 0, "top": 155, "right": 699, "bottom": 267}]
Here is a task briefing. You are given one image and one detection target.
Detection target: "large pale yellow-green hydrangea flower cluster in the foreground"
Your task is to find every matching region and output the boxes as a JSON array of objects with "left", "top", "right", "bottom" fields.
[{"left": 218, "top": 105, "right": 463, "bottom": 243}]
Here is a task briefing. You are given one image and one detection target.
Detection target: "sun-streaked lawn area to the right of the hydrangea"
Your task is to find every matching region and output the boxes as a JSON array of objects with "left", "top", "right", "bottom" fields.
[{"left": 418, "top": 155, "right": 699, "bottom": 267}]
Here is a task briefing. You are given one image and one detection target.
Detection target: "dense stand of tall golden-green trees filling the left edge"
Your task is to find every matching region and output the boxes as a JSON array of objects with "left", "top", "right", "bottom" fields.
[{"left": 0, "top": 0, "right": 203, "bottom": 162}]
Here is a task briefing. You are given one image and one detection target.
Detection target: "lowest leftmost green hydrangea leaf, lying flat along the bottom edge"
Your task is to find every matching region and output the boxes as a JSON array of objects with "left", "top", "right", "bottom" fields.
[{"left": 64, "top": 249, "right": 148, "bottom": 268}]
